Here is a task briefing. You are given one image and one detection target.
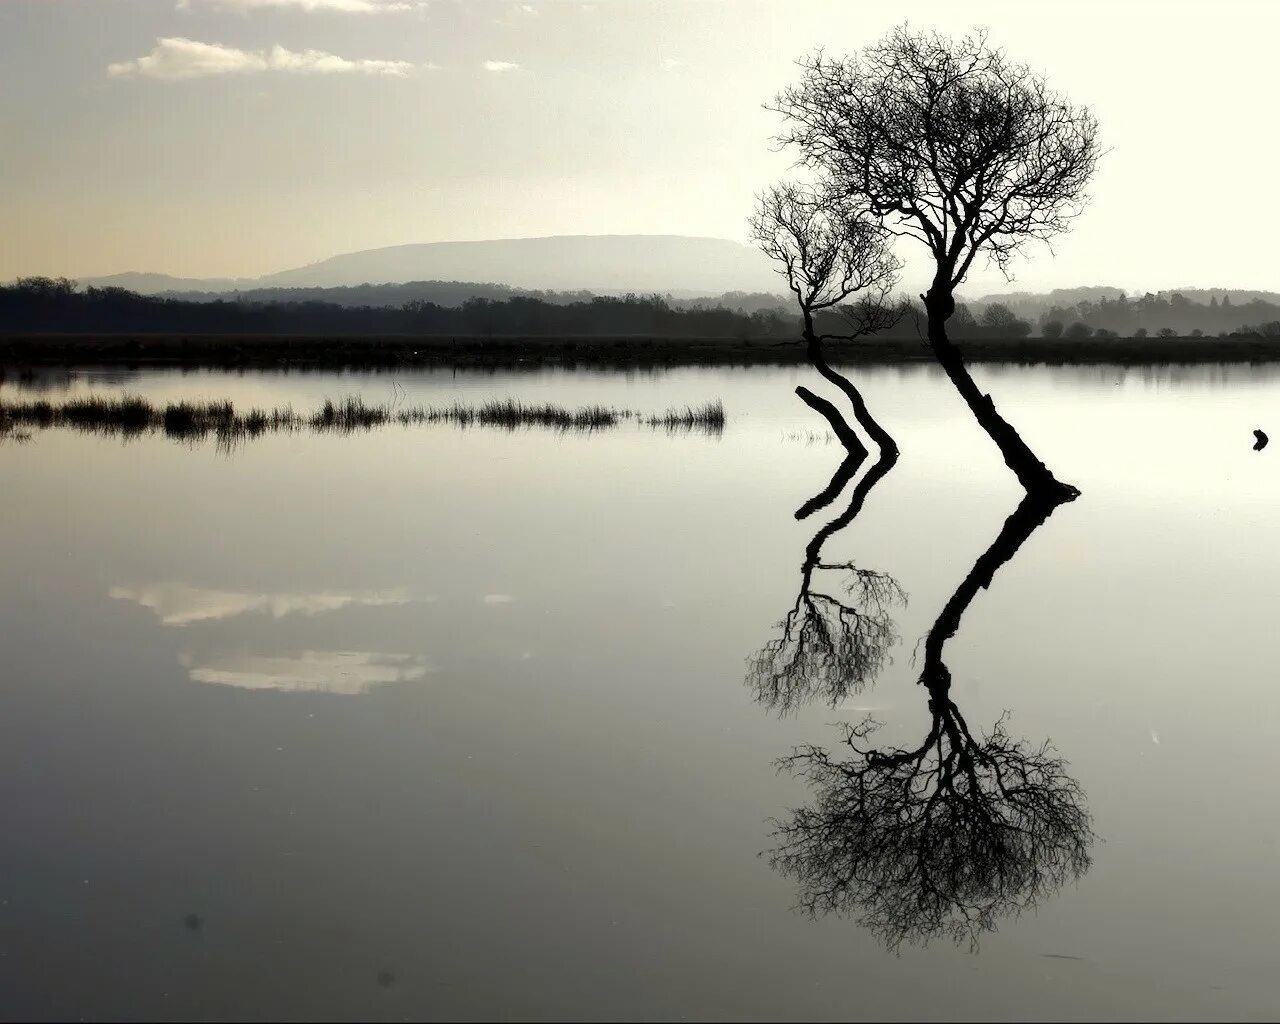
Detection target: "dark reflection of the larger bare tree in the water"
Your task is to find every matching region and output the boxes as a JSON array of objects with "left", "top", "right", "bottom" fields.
[{"left": 769, "top": 495, "right": 1094, "bottom": 950}]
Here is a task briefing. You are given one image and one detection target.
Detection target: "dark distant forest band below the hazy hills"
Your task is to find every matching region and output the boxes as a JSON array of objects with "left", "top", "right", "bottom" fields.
[{"left": 0, "top": 278, "right": 1280, "bottom": 339}]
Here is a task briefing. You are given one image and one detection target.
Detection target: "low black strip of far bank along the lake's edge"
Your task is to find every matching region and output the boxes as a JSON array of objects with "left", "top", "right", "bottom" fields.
[{"left": 0, "top": 334, "right": 1280, "bottom": 372}]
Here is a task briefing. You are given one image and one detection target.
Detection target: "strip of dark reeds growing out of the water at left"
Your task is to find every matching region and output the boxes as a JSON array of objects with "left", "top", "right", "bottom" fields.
[{"left": 0, "top": 394, "right": 724, "bottom": 448}]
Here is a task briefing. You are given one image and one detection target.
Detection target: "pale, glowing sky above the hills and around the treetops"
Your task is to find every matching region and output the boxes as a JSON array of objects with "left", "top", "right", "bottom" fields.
[{"left": 0, "top": 0, "right": 1280, "bottom": 292}]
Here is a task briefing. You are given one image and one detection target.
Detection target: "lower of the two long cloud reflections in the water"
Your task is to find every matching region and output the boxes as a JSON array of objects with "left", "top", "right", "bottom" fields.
[{"left": 182, "top": 650, "right": 429, "bottom": 694}]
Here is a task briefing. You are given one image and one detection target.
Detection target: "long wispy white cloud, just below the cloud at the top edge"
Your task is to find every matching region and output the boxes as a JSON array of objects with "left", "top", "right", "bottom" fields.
[{"left": 106, "top": 36, "right": 413, "bottom": 81}]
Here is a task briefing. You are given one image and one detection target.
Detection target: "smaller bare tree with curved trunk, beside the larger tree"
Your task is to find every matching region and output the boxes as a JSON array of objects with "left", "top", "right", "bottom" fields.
[{"left": 751, "top": 182, "right": 901, "bottom": 454}]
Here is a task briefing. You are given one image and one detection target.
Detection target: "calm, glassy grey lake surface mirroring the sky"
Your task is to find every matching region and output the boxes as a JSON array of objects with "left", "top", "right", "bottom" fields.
[{"left": 0, "top": 366, "right": 1280, "bottom": 1019}]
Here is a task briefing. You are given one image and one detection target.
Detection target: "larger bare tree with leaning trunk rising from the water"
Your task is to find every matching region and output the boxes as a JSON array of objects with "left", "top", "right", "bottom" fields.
[{"left": 771, "top": 26, "right": 1098, "bottom": 492}]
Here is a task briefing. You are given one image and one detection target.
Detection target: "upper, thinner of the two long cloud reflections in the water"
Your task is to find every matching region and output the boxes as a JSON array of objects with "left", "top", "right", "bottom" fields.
[{"left": 109, "top": 584, "right": 419, "bottom": 626}]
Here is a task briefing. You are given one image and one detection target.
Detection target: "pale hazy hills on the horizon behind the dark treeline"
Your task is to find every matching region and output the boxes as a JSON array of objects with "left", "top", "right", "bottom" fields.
[{"left": 64, "top": 234, "right": 1280, "bottom": 333}]
